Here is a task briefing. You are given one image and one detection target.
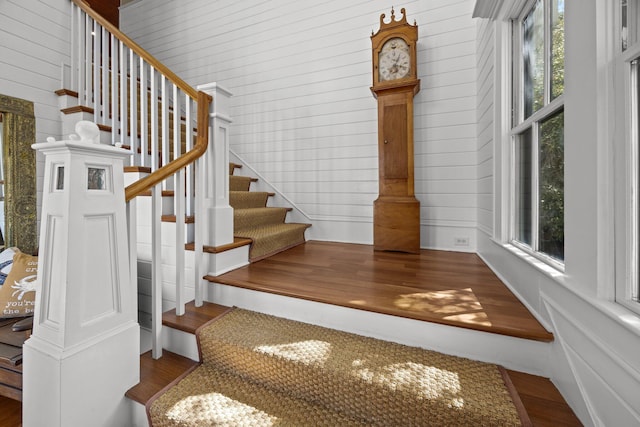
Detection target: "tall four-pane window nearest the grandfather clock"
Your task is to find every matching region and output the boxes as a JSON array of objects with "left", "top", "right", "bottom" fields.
[{"left": 511, "top": 0, "right": 564, "bottom": 268}]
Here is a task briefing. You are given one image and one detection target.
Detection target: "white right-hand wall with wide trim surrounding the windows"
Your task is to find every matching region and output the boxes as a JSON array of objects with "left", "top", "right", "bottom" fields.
[{"left": 477, "top": 0, "right": 640, "bottom": 426}]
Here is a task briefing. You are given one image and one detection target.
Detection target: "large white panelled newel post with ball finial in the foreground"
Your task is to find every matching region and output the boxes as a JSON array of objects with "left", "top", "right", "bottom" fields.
[{"left": 23, "top": 122, "right": 140, "bottom": 427}]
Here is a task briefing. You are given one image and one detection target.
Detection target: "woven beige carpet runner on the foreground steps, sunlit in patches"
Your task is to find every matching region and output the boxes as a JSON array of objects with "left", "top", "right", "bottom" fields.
[{"left": 147, "top": 308, "right": 531, "bottom": 427}]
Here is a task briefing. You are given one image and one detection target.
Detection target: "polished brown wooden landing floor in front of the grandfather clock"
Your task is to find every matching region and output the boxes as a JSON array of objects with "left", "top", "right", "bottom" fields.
[{"left": 208, "top": 241, "right": 553, "bottom": 342}]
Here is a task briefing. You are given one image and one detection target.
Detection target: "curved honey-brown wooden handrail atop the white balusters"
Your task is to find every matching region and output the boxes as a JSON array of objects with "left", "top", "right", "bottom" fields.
[{"left": 71, "top": 0, "right": 212, "bottom": 202}]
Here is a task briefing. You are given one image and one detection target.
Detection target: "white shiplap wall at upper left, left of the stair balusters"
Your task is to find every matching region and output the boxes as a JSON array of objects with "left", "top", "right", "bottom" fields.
[{"left": 0, "top": 0, "right": 71, "bottom": 231}]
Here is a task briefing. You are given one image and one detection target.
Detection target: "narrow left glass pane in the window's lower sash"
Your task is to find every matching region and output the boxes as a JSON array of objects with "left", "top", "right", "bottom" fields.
[{"left": 514, "top": 129, "right": 532, "bottom": 246}]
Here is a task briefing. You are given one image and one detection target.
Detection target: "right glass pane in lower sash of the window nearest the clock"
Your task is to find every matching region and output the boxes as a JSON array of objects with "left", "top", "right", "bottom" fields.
[{"left": 538, "top": 111, "right": 564, "bottom": 261}]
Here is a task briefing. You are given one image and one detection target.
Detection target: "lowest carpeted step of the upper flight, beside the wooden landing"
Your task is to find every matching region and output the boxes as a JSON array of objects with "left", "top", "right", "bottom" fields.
[{"left": 233, "top": 223, "right": 310, "bottom": 262}]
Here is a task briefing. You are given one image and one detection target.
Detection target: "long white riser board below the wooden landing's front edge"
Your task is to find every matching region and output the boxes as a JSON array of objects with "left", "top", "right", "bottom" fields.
[{"left": 208, "top": 283, "right": 551, "bottom": 377}]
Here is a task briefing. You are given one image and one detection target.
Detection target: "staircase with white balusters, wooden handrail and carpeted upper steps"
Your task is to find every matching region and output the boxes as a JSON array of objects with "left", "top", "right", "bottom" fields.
[{"left": 58, "top": 0, "right": 310, "bottom": 357}]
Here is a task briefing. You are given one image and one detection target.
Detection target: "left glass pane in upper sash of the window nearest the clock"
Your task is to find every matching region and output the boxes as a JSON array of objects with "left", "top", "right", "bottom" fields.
[{"left": 522, "top": 0, "right": 544, "bottom": 118}]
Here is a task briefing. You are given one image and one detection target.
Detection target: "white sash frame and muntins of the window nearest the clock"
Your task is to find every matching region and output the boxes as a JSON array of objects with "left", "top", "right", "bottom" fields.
[{"left": 507, "top": 0, "right": 564, "bottom": 272}]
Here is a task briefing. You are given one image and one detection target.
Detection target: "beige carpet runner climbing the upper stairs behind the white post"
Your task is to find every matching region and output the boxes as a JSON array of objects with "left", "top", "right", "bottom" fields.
[{"left": 229, "top": 164, "right": 310, "bottom": 262}]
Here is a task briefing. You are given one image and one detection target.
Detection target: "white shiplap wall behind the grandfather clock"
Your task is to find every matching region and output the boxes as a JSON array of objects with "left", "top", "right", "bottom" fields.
[{"left": 120, "top": 0, "right": 479, "bottom": 250}]
